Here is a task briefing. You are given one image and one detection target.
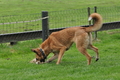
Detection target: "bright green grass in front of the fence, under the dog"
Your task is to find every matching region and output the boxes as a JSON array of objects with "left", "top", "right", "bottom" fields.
[{"left": 0, "top": 29, "right": 120, "bottom": 80}]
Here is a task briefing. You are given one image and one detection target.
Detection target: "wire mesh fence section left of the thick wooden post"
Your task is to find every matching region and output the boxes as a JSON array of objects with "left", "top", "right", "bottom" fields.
[{"left": 0, "top": 13, "right": 41, "bottom": 34}]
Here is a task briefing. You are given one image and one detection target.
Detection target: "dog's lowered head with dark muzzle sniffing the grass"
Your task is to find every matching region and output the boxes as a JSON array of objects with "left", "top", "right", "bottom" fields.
[{"left": 31, "top": 48, "right": 46, "bottom": 64}]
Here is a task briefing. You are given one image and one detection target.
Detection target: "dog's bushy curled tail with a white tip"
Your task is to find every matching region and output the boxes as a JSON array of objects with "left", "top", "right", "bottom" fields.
[{"left": 86, "top": 13, "right": 102, "bottom": 32}]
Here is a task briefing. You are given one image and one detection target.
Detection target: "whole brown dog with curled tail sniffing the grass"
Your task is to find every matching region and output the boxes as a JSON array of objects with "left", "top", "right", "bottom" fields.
[{"left": 32, "top": 13, "right": 102, "bottom": 65}]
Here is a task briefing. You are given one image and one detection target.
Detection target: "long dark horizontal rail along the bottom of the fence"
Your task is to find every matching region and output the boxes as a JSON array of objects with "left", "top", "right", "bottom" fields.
[{"left": 0, "top": 22, "right": 120, "bottom": 43}]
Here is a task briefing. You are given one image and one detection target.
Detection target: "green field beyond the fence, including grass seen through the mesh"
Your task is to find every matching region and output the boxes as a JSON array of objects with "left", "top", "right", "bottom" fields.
[{"left": 0, "top": 0, "right": 120, "bottom": 34}]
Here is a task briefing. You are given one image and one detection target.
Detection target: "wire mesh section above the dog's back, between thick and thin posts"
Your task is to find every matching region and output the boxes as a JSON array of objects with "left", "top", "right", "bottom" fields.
[{"left": 49, "top": 8, "right": 88, "bottom": 29}]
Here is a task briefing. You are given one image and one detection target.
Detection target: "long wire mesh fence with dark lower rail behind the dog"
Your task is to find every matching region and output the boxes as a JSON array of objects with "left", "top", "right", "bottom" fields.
[{"left": 0, "top": 7, "right": 120, "bottom": 43}]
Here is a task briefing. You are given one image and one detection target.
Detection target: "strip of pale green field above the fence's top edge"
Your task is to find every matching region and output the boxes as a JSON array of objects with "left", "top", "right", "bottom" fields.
[{"left": 0, "top": 0, "right": 120, "bottom": 15}]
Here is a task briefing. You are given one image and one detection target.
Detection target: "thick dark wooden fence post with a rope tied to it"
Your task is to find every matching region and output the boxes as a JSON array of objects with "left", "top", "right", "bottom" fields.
[{"left": 42, "top": 11, "right": 49, "bottom": 41}]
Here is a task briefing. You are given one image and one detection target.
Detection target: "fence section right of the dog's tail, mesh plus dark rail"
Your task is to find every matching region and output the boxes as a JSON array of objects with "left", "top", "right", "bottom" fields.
[{"left": 97, "top": 6, "right": 120, "bottom": 31}]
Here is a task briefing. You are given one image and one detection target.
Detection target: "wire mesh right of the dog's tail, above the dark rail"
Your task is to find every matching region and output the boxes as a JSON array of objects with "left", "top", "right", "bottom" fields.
[{"left": 97, "top": 6, "right": 120, "bottom": 23}]
